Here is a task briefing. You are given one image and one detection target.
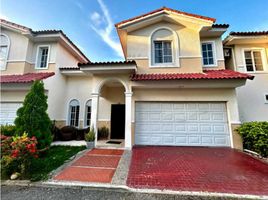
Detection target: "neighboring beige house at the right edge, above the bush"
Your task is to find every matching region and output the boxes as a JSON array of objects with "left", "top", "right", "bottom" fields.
[{"left": 223, "top": 31, "right": 268, "bottom": 122}]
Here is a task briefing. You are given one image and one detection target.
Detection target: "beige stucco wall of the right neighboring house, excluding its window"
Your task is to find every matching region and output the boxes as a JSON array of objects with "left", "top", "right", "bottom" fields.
[{"left": 230, "top": 43, "right": 268, "bottom": 122}]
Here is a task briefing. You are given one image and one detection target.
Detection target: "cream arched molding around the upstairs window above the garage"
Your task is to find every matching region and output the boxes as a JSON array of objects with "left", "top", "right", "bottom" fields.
[{"left": 148, "top": 26, "right": 180, "bottom": 66}]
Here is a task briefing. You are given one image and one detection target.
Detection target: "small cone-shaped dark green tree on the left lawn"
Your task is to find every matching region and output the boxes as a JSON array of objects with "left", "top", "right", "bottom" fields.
[{"left": 15, "top": 81, "right": 52, "bottom": 149}]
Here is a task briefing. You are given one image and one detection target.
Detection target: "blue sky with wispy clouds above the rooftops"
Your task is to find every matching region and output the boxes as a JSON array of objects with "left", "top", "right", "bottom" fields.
[{"left": 0, "top": 0, "right": 268, "bottom": 62}]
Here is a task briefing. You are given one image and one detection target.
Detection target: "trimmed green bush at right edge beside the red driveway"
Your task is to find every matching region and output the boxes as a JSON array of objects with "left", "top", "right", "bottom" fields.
[{"left": 237, "top": 122, "right": 268, "bottom": 157}]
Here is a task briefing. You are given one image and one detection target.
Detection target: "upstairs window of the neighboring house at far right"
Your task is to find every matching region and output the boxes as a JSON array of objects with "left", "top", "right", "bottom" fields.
[{"left": 244, "top": 50, "right": 263, "bottom": 72}]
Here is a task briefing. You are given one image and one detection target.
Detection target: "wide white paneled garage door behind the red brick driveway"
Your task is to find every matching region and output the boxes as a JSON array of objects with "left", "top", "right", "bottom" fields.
[{"left": 135, "top": 102, "right": 230, "bottom": 146}]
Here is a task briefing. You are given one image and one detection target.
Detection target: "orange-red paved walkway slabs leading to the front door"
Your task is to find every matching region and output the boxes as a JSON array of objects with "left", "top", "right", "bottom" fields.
[{"left": 53, "top": 149, "right": 124, "bottom": 183}]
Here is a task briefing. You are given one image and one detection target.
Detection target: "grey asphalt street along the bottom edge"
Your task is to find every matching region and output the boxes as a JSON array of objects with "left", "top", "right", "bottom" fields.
[{"left": 1, "top": 185, "right": 250, "bottom": 200}]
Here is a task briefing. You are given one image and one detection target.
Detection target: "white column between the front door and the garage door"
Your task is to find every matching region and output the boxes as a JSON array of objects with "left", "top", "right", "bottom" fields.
[{"left": 125, "top": 92, "right": 133, "bottom": 149}]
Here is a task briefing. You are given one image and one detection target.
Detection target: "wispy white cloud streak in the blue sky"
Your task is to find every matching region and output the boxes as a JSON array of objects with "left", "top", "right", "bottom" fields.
[{"left": 90, "top": 0, "right": 123, "bottom": 58}]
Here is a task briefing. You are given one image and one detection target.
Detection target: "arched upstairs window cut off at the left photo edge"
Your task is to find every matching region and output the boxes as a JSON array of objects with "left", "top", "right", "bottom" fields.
[{"left": 0, "top": 34, "right": 9, "bottom": 70}]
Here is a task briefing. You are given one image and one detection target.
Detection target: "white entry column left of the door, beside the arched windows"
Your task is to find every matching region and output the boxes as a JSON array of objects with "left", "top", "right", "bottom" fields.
[{"left": 90, "top": 93, "right": 99, "bottom": 145}]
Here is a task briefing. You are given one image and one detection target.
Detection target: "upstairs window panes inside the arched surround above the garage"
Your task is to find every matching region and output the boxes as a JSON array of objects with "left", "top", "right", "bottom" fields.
[{"left": 154, "top": 41, "right": 172, "bottom": 63}]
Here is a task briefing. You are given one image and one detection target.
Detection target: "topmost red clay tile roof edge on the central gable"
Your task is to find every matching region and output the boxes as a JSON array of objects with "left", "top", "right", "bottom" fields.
[{"left": 115, "top": 7, "right": 216, "bottom": 27}]
